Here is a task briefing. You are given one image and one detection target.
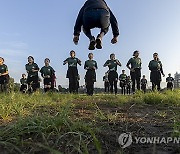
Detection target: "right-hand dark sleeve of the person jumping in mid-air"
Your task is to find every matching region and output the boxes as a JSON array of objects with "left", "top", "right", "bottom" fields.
[{"left": 109, "top": 9, "right": 119, "bottom": 37}]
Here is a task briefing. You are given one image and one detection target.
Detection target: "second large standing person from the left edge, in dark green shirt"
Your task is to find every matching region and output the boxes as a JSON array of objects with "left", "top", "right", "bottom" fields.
[{"left": 25, "top": 56, "right": 39, "bottom": 92}]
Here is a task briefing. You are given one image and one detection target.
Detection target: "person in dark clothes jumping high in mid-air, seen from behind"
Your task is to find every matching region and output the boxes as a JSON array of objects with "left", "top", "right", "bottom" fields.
[{"left": 73, "top": 0, "right": 119, "bottom": 50}]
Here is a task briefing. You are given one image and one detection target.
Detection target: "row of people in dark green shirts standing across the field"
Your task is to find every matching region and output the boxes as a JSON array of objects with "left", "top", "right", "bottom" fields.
[{"left": 0, "top": 50, "right": 174, "bottom": 95}]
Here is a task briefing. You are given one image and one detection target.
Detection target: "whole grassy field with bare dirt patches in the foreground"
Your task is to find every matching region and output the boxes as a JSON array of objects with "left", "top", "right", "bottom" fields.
[{"left": 0, "top": 90, "right": 180, "bottom": 154}]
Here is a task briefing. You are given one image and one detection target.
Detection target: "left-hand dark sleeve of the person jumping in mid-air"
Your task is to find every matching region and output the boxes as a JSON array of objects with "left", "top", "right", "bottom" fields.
[{"left": 74, "top": 6, "right": 84, "bottom": 36}]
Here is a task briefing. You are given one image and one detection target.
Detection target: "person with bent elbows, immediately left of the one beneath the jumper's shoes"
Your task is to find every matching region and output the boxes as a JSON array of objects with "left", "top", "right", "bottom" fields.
[{"left": 63, "top": 50, "right": 81, "bottom": 93}]
